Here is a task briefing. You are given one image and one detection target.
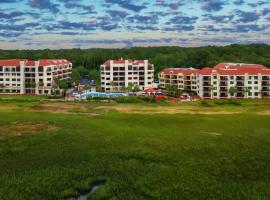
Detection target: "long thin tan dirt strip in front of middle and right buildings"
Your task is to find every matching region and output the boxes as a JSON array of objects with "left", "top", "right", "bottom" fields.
[{"left": 94, "top": 106, "right": 240, "bottom": 115}]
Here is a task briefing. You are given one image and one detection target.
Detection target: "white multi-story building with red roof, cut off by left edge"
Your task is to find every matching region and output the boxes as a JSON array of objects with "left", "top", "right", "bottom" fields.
[{"left": 0, "top": 59, "right": 72, "bottom": 95}]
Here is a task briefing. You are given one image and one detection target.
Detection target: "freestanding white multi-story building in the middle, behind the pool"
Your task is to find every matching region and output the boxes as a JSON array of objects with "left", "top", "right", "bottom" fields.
[{"left": 100, "top": 59, "right": 154, "bottom": 91}]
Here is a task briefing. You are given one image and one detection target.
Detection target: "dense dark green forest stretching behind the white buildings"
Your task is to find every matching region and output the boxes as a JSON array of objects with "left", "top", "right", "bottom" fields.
[{"left": 0, "top": 44, "right": 270, "bottom": 82}]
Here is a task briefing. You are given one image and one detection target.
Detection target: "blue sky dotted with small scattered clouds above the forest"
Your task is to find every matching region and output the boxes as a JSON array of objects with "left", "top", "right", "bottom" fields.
[{"left": 0, "top": 0, "right": 270, "bottom": 49}]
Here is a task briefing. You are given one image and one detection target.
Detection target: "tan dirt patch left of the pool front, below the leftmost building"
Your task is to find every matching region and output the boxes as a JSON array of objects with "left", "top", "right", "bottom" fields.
[{"left": 32, "top": 102, "right": 88, "bottom": 114}]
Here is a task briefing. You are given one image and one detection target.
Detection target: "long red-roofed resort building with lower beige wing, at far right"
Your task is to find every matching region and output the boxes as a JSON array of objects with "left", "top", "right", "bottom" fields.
[{"left": 159, "top": 63, "right": 270, "bottom": 99}]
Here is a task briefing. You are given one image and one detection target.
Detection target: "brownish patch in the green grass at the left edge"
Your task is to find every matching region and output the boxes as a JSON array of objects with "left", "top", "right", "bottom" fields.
[{"left": 0, "top": 122, "right": 57, "bottom": 137}]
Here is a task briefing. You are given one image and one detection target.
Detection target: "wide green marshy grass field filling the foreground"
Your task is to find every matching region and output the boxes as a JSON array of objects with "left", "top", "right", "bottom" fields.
[{"left": 0, "top": 98, "right": 270, "bottom": 200}]
